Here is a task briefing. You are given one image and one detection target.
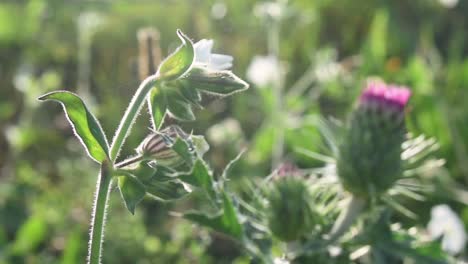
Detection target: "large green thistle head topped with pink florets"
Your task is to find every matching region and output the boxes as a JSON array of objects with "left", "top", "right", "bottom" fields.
[{"left": 337, "top": 83, "right": 411, "bottom": 197}]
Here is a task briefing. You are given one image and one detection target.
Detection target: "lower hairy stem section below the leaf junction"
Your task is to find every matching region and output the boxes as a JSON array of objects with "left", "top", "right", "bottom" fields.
[{"left": 88, "top": 163, "right": 112, "bottom": 264}]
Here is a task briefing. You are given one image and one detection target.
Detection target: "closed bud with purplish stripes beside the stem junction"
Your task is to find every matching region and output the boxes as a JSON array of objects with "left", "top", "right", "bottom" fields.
[{"left": 136, "top": 126, "right": 189, "bottom": 167}]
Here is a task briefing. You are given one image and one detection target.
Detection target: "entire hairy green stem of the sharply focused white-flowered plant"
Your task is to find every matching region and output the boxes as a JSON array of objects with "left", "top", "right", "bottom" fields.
[{"left": 88, "top": 75, "right": 158, "bottom": 264}]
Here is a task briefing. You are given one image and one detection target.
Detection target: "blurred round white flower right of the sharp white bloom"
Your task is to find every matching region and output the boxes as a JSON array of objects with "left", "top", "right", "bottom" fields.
[{"left": 247, "top": 56, "right": 281, "bottom": 87}]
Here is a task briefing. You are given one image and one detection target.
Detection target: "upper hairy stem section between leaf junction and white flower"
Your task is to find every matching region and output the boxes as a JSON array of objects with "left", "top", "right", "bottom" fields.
[{"left": 110, "top": 75, "right": 158, "bottom": 161}]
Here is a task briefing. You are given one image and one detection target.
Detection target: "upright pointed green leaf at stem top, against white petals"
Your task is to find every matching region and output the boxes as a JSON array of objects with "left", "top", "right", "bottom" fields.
[{"left": 158, "top": 30, "right": 195, "bottom": 81}]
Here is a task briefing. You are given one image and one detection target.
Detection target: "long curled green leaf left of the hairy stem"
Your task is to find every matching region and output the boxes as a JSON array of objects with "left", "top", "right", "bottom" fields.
[{"left": 39, "top": 91, "right": 109, "bottom": 163}]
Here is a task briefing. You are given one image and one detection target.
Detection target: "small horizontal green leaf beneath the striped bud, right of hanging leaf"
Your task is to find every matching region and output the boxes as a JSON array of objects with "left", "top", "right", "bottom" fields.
[{"left": 145, "top": 180, "right": 188, "bottom": 202}]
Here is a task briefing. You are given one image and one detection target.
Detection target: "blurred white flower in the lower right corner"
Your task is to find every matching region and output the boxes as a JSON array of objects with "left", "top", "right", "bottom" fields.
[{"left": 427, "top": 204, "right": 466, "bottom": 254}]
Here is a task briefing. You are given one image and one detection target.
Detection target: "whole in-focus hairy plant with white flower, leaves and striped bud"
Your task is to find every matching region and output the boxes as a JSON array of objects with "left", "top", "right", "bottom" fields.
[{"left": 39, "top": 30, "right": 248, "bottom": 263}]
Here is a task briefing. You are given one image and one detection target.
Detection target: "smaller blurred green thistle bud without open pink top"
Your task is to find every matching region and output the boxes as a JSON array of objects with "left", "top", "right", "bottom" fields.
[{"left": 267, "top": 177, "right": 317, "bottom": 241}]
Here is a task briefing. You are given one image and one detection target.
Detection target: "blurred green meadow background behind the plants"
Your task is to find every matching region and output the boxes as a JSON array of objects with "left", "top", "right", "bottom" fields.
[{"left": 0, "top": 0, "right": 468, "bottom": 263}]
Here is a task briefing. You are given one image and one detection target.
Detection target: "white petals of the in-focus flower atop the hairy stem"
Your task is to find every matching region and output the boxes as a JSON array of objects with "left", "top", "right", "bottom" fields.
[{"left": 193, "top": 39, "right": 234, "bottom": 70}]
